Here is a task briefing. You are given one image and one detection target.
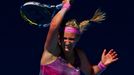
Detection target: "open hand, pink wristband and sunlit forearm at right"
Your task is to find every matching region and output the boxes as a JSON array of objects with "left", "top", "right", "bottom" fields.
[{"left": 93, "top": 49, "right": 118, "bottom": 75}]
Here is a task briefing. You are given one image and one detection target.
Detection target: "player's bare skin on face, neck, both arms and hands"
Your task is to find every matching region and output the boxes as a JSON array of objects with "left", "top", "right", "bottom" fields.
[{"left": 41, "top": 0, "right": 118, "bottom": 75}]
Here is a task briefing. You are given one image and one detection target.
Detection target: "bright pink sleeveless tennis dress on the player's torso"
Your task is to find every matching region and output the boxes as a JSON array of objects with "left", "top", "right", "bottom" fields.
[{"left": 40, "top": 57, "right": 80, "bottom": 75}]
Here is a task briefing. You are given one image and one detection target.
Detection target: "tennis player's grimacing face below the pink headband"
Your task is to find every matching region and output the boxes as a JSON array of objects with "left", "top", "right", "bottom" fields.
[{"left": 63, "top": 32, "right": 79, "bottom": 51}]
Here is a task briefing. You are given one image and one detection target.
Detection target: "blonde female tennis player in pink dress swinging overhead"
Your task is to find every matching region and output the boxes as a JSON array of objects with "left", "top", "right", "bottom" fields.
[{"left": 40, "top": 0, "right": 118, "bottom": 75}]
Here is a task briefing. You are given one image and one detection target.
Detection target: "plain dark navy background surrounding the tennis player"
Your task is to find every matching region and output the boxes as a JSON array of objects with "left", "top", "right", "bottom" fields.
[{"left": 0, "top": 0, "right": 134, "bottom": 75}]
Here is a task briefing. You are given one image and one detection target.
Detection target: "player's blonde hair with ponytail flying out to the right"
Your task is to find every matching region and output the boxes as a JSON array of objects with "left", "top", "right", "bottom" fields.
[{"left": 66, "top": 9, "right": 106, "bottom": 34}]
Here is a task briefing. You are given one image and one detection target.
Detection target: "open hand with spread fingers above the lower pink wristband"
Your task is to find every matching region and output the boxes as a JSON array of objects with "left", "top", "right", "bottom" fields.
[{"left": 101, "top": 49, "right": 118, "bottom": 66}]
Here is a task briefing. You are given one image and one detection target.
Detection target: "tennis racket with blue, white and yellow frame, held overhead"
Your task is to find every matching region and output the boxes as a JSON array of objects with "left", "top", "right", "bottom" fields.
[{"left": 20, "top": 1, "right": 62, "bottom": 27}]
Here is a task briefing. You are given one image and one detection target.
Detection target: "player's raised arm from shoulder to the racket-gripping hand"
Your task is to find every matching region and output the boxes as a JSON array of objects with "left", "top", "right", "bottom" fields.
[{"left": 41, "top": 0, "right": 70, "bottom": 63}]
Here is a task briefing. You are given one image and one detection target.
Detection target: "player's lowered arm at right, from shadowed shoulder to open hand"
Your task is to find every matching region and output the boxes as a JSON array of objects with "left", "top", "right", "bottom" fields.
[{"left": 77, "top": 49, "right": 118, "bottom": 75}]
